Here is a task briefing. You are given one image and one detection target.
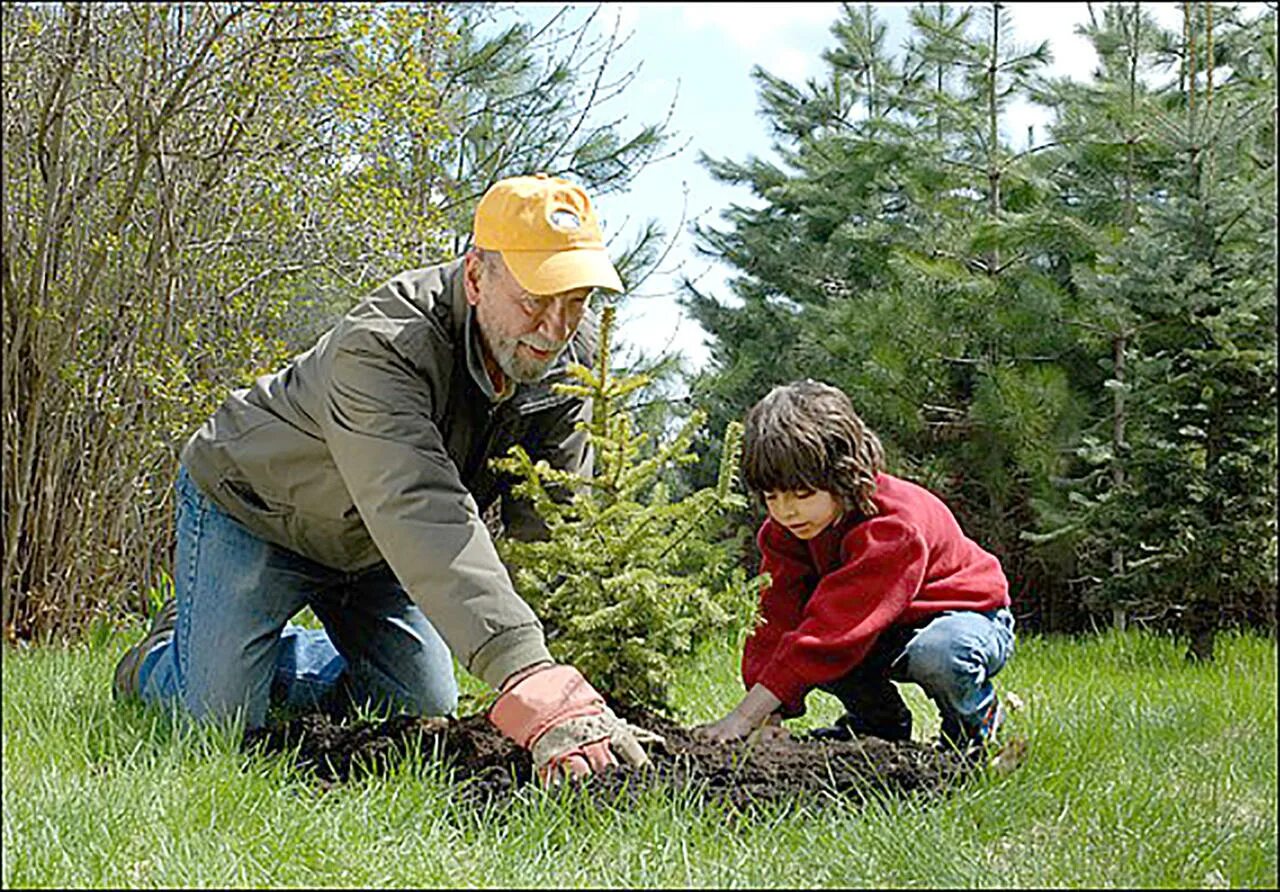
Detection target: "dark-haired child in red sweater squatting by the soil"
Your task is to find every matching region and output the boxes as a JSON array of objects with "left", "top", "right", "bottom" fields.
[{"left": 699, "top": 380, "right": 1014, "bottom": 751}]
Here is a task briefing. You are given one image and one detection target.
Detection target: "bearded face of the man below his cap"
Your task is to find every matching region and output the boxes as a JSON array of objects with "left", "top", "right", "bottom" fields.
[{"left": 465, "top": 251, "right": 591, "bottom": 384}]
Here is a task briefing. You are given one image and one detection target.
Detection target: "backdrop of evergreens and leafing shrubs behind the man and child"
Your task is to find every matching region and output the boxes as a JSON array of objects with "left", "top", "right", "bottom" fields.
[{"left": 3, "top": 3, "right": 1276, "bottom": 658}]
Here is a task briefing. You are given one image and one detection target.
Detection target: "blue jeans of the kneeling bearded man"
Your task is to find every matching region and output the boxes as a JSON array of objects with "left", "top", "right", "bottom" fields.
[{"left": 138, "top": 468, "right": 458, "bottom": 728}]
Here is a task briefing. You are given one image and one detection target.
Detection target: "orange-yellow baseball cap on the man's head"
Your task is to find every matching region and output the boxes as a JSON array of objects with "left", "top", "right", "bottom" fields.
[{"left": 472, "top": 174, "right": 622, "bottom": 294}]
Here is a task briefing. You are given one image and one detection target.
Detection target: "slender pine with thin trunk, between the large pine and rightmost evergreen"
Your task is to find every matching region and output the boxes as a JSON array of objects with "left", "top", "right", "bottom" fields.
[{"left": 1024, "top": 3, "right": 1167, "bottom": 630}]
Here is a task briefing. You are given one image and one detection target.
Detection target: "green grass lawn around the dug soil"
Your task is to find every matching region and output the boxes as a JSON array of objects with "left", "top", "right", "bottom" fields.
[{"left": 3, "top": 627, "right": 1277, "bottom": 888}]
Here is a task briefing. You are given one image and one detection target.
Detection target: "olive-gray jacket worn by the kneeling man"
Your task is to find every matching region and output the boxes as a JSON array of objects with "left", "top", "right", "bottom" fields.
[{"left": 182, "top": 260, "right": 596, "bottom": 687}]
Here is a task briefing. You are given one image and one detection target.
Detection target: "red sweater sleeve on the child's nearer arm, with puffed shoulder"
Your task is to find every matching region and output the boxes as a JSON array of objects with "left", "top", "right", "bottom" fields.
[{"left": 758, "top": 517, "right": 928, "bottom": 712}]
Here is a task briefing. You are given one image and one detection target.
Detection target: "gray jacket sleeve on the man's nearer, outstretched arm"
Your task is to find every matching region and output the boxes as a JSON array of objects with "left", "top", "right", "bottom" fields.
[{"left": 319, "top": 331, "right": 550, "bottom": 687}]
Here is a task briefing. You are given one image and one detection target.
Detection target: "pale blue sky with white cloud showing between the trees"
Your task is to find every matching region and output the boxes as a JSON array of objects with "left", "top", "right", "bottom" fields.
[{"left": 506, "top": 3, "right": 1198, "bottom": 369}]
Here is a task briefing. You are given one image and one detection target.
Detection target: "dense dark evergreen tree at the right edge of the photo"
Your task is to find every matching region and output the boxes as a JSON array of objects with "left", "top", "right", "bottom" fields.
[{"left": 1044, "top": 5, "right": 1276, "bottom": 659}]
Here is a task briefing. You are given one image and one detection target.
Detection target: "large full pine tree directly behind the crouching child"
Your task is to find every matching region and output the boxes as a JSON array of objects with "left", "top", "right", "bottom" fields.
[{"left": 687, "top": 4, "right": 1082, "bottom": 621}]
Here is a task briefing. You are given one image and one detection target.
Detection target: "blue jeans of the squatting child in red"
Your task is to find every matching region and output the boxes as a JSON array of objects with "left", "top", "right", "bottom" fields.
[{"left": 819, "top": 608, "right": 1014, "bottom": 740}]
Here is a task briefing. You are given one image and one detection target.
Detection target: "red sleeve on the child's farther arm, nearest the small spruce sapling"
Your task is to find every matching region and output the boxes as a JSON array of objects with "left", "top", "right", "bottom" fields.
[{"left": 742, "top": 520, "right": 815, "bottom": 718}]
